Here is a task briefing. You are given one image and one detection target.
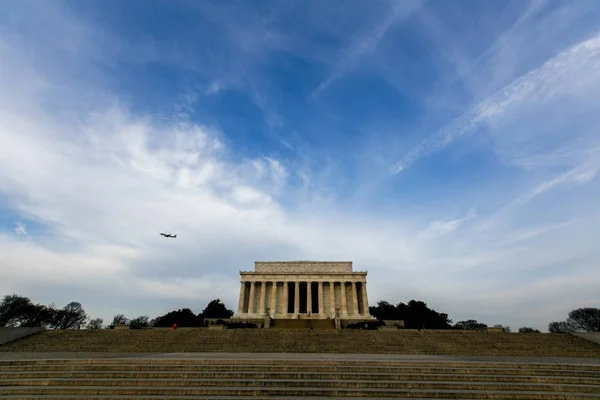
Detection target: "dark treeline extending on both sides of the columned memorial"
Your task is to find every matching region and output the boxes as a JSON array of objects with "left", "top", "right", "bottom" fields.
[{"left": 0, "top": 294, "right": 600, "bottom": 333}]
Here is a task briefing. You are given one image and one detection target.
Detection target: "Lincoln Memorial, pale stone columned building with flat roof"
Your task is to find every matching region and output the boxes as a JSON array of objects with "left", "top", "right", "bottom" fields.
[{"left": 234, "top": 261, "right": 375, "bottom": 322}]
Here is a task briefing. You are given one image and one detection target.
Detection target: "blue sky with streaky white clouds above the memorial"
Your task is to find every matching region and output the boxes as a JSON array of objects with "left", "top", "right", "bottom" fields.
[{"left": 0, "top": 0, "right": 600, "bottom": 329}]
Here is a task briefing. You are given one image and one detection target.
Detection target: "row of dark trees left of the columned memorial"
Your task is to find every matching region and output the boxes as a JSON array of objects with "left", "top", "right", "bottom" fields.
[{"left": 0, "top": 294, "right": 233, "bottom": 329}]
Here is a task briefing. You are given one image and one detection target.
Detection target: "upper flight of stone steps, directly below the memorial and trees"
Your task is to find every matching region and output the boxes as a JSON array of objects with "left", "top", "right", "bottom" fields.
[{"left": 0, "top": 328, "right": 600, "bottom": 358}]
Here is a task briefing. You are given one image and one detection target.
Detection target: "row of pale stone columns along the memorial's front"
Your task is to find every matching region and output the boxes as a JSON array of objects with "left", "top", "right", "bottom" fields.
[{"left": 238, "top": 281, "right": 369, "bottom": 316}]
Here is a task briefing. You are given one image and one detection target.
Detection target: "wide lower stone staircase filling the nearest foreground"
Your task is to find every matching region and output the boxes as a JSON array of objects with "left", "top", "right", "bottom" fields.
[{"left": 0, "top": 358, "right": 600, "bottom": 400}]
